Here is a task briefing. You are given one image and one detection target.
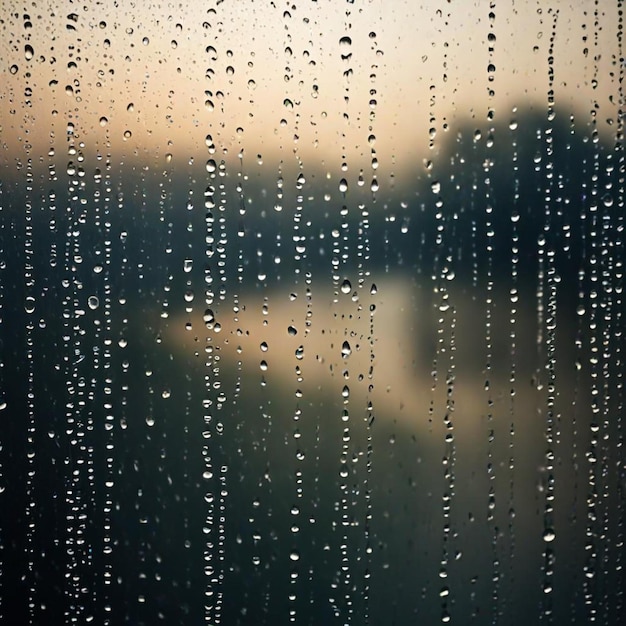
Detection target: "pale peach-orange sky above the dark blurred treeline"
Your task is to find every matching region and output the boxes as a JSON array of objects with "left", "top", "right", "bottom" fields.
[{"left": 0, "top": 0, "right": 619, "bottom": 176}]
